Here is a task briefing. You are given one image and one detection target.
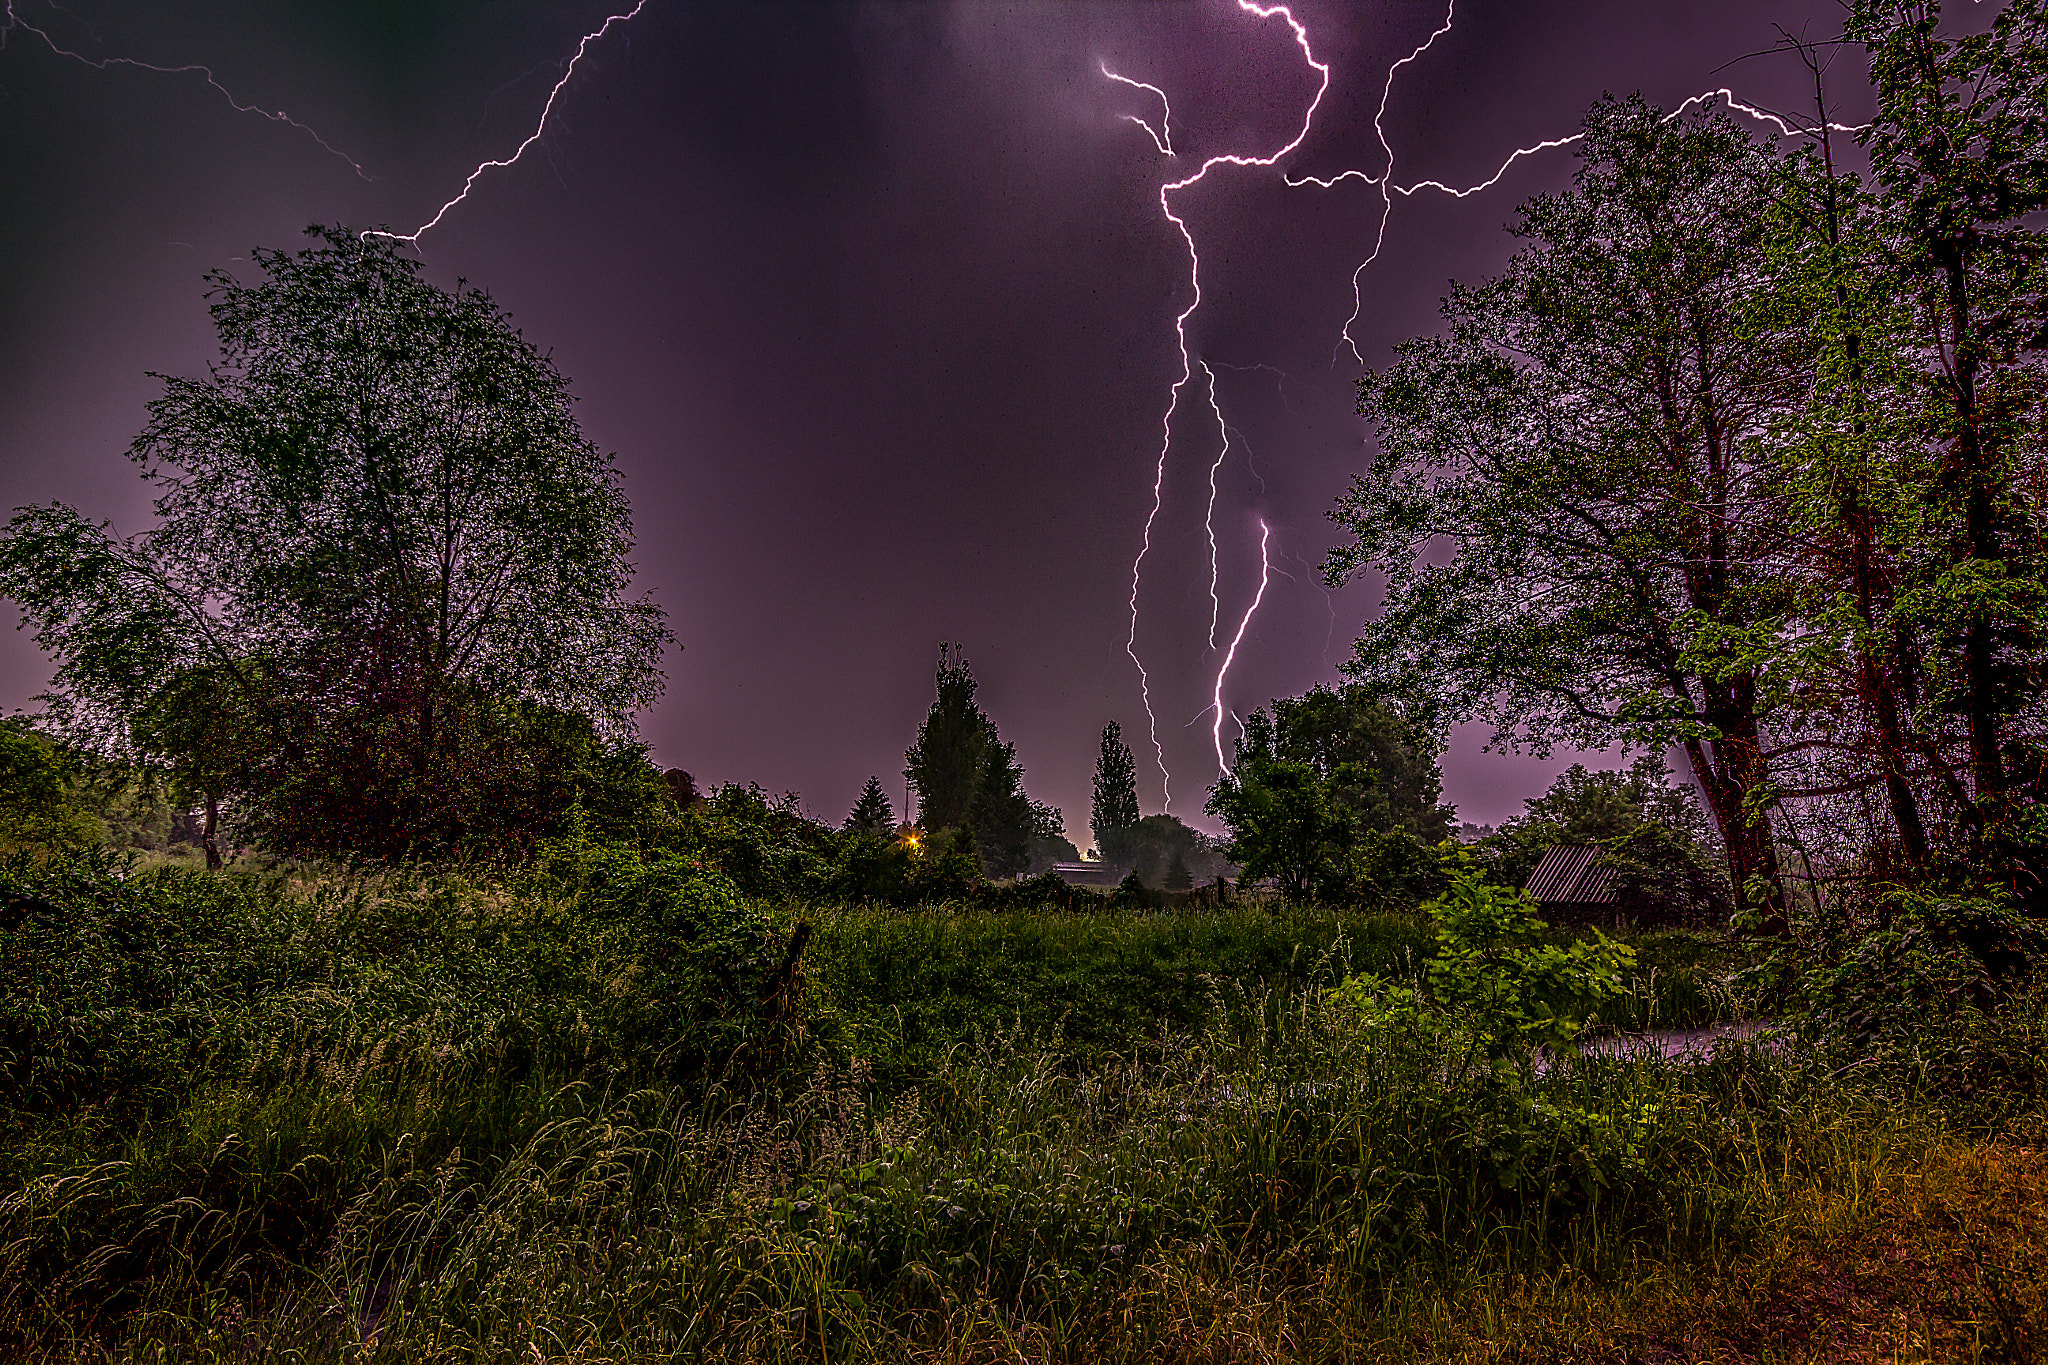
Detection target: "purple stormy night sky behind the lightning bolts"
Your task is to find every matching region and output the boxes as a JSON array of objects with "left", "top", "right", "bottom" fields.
[{"left": 0, "top": 0, "right": 1870, "bottom": 847}]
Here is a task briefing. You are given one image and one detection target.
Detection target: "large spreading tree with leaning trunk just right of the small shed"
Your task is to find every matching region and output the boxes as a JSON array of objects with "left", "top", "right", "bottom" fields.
[{"left": 1327, "top": 98, "right": 1815, "bottom": 933}]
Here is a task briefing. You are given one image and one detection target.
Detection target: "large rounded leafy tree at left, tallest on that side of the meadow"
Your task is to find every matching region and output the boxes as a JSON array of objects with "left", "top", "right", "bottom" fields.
[{"left": 0, "top": 229, "right": 672, "bottom": 855}]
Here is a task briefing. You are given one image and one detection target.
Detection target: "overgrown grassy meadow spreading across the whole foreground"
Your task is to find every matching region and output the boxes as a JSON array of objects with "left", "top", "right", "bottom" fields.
[{"left": 0, "top": 853, "right": 2048, "bottom": 1361}]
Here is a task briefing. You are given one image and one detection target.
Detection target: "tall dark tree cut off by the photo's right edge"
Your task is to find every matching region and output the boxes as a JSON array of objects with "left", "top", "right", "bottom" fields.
[{"left": 1849, "top": 0, "right": 2048, "bottom": 875}]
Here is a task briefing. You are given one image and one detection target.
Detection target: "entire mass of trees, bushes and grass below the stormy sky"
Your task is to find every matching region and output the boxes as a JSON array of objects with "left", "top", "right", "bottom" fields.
[{"left": 0, "top": 0, "right": 2048, "bottom": 1363}]
